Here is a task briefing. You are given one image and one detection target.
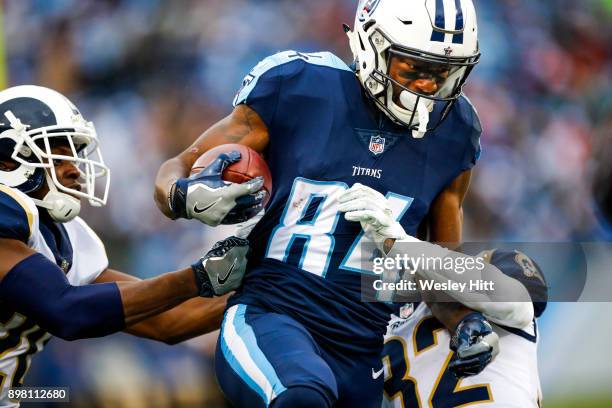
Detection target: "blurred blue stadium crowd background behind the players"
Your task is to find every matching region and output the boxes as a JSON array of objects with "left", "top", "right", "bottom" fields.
[{"left": 2, "top": 0, "right": 612, "bottom": 407}]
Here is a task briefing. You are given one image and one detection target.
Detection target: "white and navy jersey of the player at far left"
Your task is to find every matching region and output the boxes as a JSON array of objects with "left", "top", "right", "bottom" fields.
[{"left": 0, "top": 184, "right": 108, "bottom": 407}]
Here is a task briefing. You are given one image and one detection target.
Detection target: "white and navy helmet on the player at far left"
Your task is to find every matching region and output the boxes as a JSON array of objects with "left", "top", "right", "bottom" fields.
[{"left": 0, "top": 85, "right": 110, "bottom": 222}]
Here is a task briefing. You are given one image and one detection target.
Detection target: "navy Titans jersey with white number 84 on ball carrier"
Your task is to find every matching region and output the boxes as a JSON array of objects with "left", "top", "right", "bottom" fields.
[{"left": 230, "top": 51, "right": 481, "bottom": 350}]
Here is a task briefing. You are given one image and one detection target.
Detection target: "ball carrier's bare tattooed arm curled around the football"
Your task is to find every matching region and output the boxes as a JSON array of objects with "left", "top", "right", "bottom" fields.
[{"left": 154, "top": 104, "right": 269, "bottom": 217}]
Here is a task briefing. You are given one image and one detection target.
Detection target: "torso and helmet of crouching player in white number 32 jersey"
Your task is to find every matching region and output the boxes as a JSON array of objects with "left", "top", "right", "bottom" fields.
[{"left": 382, "top": 249, "right": 547, "bottom": 408}]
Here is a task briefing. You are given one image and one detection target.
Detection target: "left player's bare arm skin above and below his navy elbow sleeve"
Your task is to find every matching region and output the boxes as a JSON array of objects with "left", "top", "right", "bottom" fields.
[{"left": 0, "top": 239, "right": 198, "bottom": 326}]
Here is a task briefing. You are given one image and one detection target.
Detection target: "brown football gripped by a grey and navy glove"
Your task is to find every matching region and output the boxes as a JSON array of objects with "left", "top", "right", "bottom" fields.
[{"left": 169, "top": 144, "right": 272, "bottom": 226}]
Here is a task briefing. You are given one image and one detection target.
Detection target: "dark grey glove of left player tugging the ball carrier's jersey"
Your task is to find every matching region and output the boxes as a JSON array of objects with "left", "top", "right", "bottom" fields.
[{"left": 191, "top": 237, "right": 249, "bottom": 297}]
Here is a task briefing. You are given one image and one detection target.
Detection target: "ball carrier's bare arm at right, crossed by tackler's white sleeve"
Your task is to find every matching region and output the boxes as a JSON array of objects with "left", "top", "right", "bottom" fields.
[{"left": 427, "top": 170, "right": 473, "bottom": 332}]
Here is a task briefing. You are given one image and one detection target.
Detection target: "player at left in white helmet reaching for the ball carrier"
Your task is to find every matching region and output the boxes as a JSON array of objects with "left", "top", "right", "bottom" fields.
[{"left": 0, "top": 85, "right": 248, "bottom": 407}]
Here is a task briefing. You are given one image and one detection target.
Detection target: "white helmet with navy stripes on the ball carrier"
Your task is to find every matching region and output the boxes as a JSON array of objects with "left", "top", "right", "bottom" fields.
[{"left": 345, "top": 0, "right": 480, "bottom": 137}]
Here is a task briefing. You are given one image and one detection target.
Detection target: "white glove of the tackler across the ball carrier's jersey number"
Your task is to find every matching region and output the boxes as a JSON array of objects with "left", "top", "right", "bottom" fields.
[{"left": 339, "top": 183, "right": 408, "bottom": 254}]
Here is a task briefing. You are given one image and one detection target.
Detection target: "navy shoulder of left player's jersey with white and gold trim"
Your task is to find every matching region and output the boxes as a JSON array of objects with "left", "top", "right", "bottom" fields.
[{"left": 0, "top": 184, "right": 38, "bottom": 244}]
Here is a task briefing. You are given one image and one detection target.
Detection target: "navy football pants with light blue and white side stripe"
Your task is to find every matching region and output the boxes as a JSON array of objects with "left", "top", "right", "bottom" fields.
[{"left": 215, "top": 304, "right": 383, "bottom": 408}]
